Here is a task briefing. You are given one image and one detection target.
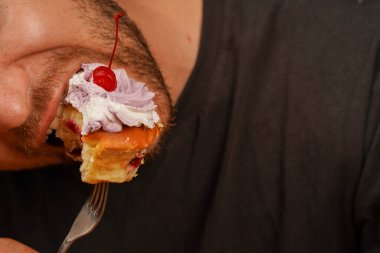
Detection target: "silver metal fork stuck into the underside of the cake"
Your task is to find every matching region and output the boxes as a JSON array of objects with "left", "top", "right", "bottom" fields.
[{"left": 58, "top": 183, "right": 109, "bottom": 253}]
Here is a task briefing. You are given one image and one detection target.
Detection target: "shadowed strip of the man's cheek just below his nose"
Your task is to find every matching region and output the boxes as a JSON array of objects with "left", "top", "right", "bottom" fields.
[{"left": 0, "top": 145, "right": 73, "bottom": 170}]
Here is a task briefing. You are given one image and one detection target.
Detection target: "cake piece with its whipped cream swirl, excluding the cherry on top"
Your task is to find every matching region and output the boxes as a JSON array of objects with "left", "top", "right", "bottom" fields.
[{"left": 56, "top": 63, "right": 163, "bottom": 183}]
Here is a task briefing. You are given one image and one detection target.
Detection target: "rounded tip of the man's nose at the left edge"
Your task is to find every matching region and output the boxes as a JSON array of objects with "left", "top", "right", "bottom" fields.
[{"left": 0, "top": 66, "right": 31, "bottom": 132}]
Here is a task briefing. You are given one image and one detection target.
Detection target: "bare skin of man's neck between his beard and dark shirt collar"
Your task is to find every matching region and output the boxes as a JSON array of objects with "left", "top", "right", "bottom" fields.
[{"left": 118, "top": 0, "right": 202, "bottom": 102}]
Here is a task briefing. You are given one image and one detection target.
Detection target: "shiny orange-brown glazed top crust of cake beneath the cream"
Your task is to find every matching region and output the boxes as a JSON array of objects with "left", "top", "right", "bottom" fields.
[{"left": 81, "top": 126, "right": 160, "bottom": 150}]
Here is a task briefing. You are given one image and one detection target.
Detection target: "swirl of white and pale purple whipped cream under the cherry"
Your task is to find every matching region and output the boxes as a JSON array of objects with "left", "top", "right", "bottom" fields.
[{"left": 65, "top": 63, "right": 160, "bottom": 135}]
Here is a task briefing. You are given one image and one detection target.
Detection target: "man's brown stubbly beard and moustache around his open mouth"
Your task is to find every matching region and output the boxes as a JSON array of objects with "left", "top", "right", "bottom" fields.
[{"left": 12, "top": 1, "right": 172, "bottom": 156}]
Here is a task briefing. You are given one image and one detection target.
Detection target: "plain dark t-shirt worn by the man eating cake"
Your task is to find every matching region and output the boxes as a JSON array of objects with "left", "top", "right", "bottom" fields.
[{"left": 0, "top": 0, "right": 380, "bottom": 253}]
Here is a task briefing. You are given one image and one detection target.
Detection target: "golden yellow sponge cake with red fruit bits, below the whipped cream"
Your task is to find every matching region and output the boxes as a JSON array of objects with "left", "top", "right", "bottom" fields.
[{"left": 56, "top": 105, "right": 160, "bottom": 184}]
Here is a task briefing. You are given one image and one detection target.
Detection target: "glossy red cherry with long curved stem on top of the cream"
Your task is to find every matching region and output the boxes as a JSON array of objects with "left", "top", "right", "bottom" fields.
[{"left": 92, "top": 12, "right": 124, "bottom": 92}]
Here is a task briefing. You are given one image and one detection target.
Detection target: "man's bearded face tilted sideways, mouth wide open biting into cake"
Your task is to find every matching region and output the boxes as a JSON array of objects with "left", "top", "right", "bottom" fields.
[{"left": 0, "top": 0, "right": 170, "bottom": 169}]
